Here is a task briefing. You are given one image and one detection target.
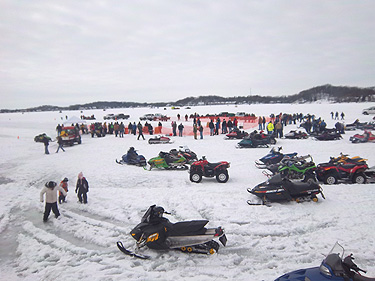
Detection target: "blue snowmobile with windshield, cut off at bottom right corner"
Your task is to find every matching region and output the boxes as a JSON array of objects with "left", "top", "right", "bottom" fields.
[{"left": 275, "top": 242, "right": 375, "bottom": 281}]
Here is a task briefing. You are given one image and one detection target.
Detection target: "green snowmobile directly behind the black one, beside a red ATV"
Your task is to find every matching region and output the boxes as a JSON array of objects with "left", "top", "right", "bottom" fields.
[{"left": 263, "top": 155, "right": 317, "bottom": 182}]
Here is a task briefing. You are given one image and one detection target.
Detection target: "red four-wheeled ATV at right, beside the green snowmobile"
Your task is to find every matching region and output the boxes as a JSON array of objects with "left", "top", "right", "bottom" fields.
[{"left": 315, "top": 162, "right": 368, "bottom": 184}]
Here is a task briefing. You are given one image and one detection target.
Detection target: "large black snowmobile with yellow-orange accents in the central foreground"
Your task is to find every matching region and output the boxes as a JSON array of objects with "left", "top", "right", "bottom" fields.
[{"left": 117, "top": 205, "right": 227, "bottom": 259}]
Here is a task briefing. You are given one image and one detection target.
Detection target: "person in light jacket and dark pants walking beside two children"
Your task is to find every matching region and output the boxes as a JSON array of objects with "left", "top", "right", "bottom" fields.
[{"left": 40, "top": 181, "right": 67, "bottom": 222}]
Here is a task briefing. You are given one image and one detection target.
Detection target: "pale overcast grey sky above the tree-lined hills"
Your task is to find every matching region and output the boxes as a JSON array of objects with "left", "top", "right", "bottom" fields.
[{"left": 0, "top": 0, "right": 375, "bottom": 109}]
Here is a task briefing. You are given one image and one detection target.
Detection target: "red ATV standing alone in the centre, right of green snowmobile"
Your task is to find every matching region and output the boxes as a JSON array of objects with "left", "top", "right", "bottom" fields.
[{"left": 189, "top": 156, "right": 230, "bottom": 183}]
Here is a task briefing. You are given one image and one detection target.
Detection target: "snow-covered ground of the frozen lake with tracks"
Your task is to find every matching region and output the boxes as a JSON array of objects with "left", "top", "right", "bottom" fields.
[{"left": 0, "top": 101, "right": 375, "bottom": 280}]
